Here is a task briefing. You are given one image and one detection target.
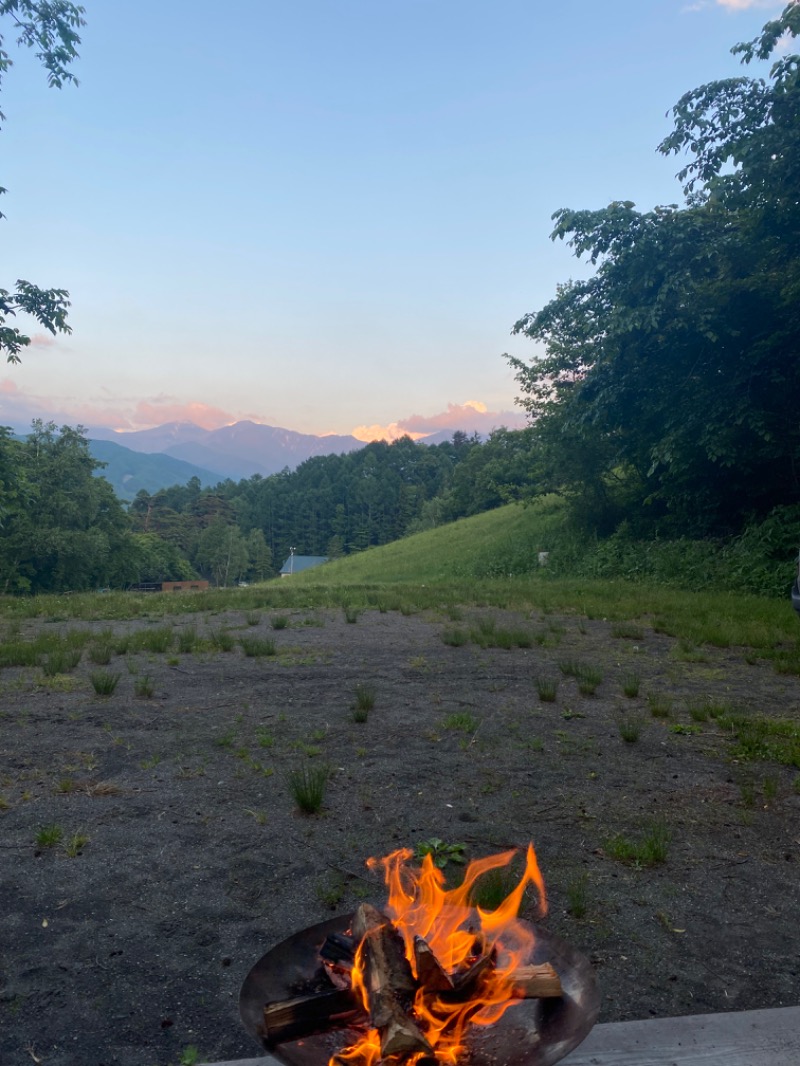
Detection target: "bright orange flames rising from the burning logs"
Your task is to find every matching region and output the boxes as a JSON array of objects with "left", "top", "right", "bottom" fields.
[{"left": 328, "top": 844, "right": 547, "bottom": 1066}]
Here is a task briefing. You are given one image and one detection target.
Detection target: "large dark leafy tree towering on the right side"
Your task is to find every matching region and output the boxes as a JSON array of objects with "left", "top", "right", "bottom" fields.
[{"left": 510, "top": 3, "right": 800, "bottom": 534}]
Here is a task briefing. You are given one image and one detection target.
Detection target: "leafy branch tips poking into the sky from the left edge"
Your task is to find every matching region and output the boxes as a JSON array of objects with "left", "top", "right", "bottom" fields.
[{"left": 0, "top": 0, "right": 85, "bottom": 362}]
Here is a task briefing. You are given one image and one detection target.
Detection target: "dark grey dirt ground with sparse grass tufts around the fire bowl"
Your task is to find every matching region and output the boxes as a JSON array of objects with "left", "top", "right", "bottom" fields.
[{"left": 0, "top": 610, "right": 800, "bottom": 1066}]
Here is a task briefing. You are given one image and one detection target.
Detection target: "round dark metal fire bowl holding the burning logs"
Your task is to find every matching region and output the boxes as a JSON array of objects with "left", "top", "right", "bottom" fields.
[{"left": 239, "top": 915, "right": 599, "bottom": 1066}]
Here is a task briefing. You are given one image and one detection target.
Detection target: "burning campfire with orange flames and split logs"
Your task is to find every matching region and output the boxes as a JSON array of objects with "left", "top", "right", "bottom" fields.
[{"left": 261, "top": 845, "right": 571, "bottom": 1066}]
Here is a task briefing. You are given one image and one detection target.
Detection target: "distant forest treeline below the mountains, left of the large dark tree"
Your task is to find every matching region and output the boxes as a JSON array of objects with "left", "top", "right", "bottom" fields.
[{"left": 0, "top": 421, "right": 533, "bottom": 593}]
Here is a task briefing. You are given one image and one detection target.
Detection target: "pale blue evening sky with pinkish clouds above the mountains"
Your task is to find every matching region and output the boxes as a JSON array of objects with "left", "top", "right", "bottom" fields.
[{"left": 0, "top": 0, "right": 783, "bottom": 437}]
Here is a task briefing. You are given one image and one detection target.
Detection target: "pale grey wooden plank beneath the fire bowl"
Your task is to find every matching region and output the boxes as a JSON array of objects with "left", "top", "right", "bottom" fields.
[{"left": 200, "top": 1006, "right": 800, "bottom": 1066}]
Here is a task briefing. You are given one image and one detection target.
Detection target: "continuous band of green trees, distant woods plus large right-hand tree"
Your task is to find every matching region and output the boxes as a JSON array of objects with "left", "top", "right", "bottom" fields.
[{"left": 0, "top": 3, "right": 800, "bottom": 593}]
